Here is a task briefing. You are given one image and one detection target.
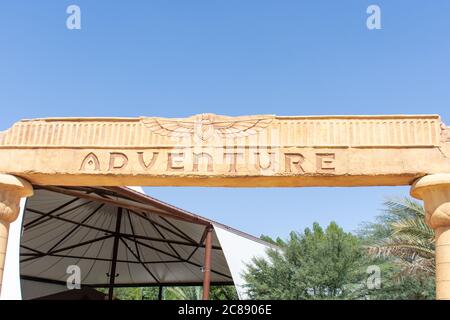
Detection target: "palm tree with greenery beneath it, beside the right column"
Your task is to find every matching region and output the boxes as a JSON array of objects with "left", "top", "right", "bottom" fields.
[{"left": 359, "top": 198, "right": 435, "bottom": 300}]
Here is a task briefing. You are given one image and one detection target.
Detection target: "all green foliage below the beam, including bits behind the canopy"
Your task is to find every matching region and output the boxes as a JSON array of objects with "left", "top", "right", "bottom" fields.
[{"left": 97, "top": 198, "right": 435, "bottom": 300}]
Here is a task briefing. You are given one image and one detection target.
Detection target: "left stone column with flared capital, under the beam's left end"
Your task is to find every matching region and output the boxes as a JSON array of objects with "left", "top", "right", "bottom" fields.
[{"left": 0, "top": 174, "right": 33, "bottom": 292}]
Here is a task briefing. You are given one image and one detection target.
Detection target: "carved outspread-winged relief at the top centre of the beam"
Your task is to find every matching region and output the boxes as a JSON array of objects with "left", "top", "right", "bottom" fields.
[{"left": 141, "top": 113, "right": 274, "bottom": 141}]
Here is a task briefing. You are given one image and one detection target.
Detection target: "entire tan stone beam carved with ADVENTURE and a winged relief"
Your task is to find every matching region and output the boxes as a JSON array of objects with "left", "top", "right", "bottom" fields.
[{"left": 0, "top": 114, "right": 450, "bottom": 187}]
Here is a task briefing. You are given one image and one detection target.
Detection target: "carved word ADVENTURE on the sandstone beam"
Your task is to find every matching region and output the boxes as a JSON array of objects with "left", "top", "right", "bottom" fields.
[{"left": 79, "top": 150, "right": 335, "bottom": 174}]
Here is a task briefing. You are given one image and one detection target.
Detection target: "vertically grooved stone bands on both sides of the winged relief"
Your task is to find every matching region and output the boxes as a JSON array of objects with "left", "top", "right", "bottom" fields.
[{"left": 0, "top": 116, "right": 441, "bottom": 148}]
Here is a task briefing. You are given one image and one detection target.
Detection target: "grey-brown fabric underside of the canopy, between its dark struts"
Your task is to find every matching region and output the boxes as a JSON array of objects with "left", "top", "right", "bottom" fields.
[{"left": 20, "top": 186, "right": 231, "bottom": 286}]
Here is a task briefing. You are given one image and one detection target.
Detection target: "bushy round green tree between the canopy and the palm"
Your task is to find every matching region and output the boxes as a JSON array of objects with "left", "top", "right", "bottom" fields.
[{"left": 244, "top": 222, "right": 366, "bottom": 300}]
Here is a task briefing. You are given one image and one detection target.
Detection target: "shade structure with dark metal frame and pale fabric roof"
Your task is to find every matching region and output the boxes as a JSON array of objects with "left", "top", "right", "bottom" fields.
[{"left": 12, "top": 186, "right": 270, "bottom": 295}]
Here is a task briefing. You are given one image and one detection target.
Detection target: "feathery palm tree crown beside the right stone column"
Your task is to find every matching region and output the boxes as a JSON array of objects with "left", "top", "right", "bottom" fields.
[{"left": 366, "top": 198, "right": 435, "bottom": 277}]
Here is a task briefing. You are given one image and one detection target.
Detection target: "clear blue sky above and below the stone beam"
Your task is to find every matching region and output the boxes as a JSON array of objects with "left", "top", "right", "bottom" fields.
[{"left": 0, "top": 0, "right": 450, "bottom": 237}]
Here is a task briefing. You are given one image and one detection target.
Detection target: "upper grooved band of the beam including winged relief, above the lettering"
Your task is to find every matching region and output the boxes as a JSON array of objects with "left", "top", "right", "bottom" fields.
[{"left": 0, "top": 114, "right": 441, "bottom": 148}]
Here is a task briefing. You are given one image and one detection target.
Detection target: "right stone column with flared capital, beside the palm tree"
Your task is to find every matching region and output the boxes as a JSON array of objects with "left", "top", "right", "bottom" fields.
[{"left": 411, "top": 174, "right": 450, "bottom": 300}]
